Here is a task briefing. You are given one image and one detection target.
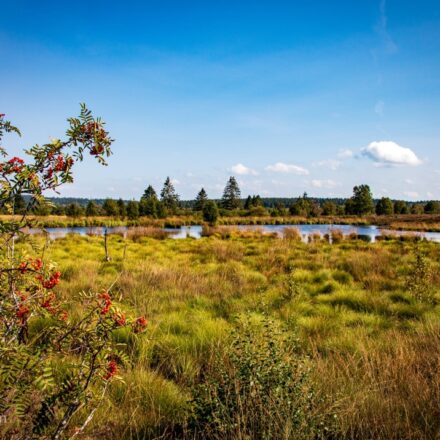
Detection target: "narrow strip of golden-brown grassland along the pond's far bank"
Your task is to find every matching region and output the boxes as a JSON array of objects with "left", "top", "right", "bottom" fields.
[{"left": 0, "top": 214, "right": 440, "bottom": 232}]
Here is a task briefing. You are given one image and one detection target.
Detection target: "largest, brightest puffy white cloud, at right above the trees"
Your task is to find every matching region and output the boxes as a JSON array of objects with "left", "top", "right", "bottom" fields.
[{"left": 361, "top": 141, "right": 422, "bottom": 166}]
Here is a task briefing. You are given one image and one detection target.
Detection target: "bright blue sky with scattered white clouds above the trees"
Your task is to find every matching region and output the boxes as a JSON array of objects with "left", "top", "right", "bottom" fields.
[{"left": 0, "top": 0, "right": 440, "bottom": 200}]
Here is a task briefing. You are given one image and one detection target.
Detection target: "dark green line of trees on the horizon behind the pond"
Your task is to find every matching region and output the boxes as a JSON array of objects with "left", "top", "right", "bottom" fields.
[{"left": 6, "top": 176, "right": 440, "bottom": 222}]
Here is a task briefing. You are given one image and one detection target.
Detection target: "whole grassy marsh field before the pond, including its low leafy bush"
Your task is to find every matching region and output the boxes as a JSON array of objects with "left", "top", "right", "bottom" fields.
[{"left": 15, "top": 232, "right": 440, "bottom": 439}]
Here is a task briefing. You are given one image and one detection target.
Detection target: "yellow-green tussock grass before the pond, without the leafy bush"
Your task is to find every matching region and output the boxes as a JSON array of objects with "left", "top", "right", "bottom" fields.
[{"left": 14, "top": 234, "right": 440, "bottom": 439}]
